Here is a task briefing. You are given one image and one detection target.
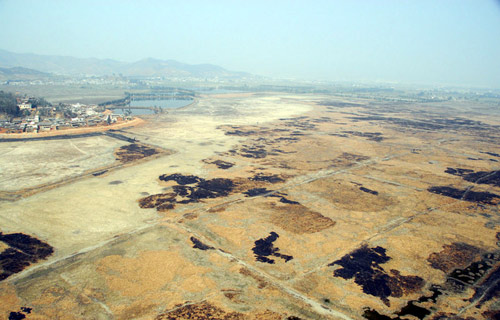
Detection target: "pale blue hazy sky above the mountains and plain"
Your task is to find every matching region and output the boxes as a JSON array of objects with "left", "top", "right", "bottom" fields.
[{"left": 0, "top": 0, "right": 500, "bottom": 88}]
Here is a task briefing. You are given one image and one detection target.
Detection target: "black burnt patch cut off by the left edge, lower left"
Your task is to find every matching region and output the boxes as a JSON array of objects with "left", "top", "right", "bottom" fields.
[{"left": 0, "top": 232, "right": 54, "bottom": 280}]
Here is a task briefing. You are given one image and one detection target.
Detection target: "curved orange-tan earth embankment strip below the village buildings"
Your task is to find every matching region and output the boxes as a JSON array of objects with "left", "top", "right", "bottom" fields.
[{"left": 0, "top": 117, "right": 146, "bottom": 140}]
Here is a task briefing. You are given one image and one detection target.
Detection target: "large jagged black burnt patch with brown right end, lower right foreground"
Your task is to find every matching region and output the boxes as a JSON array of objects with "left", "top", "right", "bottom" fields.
[{"left": 328, "top": 245, "right": 424, "bottom": 306}]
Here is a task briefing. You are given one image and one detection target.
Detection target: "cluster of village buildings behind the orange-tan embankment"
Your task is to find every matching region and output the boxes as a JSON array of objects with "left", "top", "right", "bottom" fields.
[{"left": 0, "top": 98, "right": 131, "bottom": 133}]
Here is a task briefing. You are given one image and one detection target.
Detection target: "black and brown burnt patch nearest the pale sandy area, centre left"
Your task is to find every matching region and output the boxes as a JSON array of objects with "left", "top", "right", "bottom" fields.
[{"left": 139, "top": 174, "right": 235, "bottom": 211}]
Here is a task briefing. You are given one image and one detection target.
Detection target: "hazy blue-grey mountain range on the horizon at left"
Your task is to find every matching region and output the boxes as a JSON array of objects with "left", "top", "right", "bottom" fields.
[{"left": 0, "top": 49, "right": 252, "bottom": 78}]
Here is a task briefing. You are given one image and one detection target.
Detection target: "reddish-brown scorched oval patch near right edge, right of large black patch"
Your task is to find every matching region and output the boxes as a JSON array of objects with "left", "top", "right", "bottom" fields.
[{"left": 427, "top": 242, "right": 483, "bottom": 273}]
